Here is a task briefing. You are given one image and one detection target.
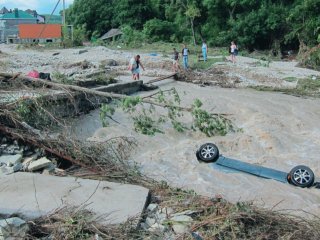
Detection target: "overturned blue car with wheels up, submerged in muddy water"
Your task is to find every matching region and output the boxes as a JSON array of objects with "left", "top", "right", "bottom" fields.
[{"left": 196, "top": 143, "right": 319, "bottom": 188}]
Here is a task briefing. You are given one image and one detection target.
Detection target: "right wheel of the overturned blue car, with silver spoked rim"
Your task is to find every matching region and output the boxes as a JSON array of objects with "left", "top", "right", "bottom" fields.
[{"left": 288, "top": 165, "right": 314, "bottom": 188}]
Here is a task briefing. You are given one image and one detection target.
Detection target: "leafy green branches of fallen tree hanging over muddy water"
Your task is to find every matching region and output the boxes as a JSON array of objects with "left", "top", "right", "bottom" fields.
[{"left": 100, "top": 88, "right": 234, "bottom": 137}]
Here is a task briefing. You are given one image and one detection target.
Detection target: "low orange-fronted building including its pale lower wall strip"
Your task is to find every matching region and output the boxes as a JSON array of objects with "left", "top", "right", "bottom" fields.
[{"left": 19, "top": 24, "right": 62, "bottom": 43}]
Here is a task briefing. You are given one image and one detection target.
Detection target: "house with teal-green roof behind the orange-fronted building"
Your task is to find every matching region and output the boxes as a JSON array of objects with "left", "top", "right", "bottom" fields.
[{"left": 0, "top": 8, "right": 37, "bottom": 43}]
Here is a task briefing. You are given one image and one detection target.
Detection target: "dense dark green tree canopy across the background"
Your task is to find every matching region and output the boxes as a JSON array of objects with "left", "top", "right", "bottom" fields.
[{"left": 67, "top": 0, "right": 320, "bottom": 49}]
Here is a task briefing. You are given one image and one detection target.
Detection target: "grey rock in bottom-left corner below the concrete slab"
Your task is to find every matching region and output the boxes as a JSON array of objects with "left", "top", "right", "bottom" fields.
[{"left": 0, "top": 217, "right": 29, "bottom": 240}]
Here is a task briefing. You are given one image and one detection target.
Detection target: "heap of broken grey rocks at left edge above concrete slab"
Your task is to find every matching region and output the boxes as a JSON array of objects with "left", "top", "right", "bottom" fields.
[{"left": 0, "top": 137, "right": 62, "bottom": 175}]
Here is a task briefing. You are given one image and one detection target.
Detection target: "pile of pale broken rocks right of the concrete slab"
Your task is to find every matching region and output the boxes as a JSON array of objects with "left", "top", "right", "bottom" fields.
[{"left": 140, "top": 203, "right": 201, "bottom": 239}]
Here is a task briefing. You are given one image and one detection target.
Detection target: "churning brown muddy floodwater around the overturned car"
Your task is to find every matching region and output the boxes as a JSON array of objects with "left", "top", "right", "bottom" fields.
[{"left": 74, "top": 80, "right": 320, "bottom": 215}]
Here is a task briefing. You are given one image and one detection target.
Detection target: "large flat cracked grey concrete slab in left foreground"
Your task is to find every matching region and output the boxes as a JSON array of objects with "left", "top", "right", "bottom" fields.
[{"left": 0, "top": 172, "right": 149, "bottom": 224}]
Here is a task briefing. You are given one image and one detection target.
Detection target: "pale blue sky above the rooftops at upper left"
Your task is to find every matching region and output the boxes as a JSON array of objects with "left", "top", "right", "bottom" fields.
[{"left": 0, "top": 0, "right": 74, "bottom": 14}]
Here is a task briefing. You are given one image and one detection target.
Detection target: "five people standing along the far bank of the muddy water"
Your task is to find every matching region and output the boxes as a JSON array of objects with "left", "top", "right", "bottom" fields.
[{"left": 128, "top": 41, "right": 238, "bottom": 80}]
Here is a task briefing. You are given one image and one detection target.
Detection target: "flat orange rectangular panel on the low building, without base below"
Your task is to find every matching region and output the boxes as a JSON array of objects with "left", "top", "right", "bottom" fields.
[{"left": 19, "top": 24, "right": 61, "bottom": 39}]
